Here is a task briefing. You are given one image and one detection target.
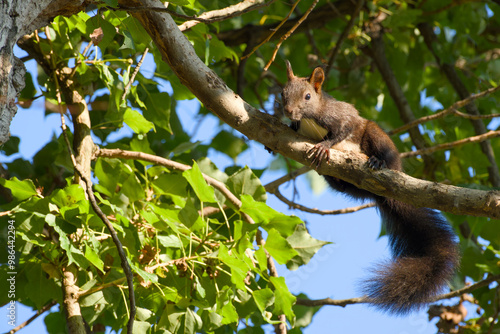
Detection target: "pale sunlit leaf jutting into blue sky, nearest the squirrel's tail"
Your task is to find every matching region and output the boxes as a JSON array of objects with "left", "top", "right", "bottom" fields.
[{"left": 286, "top": 225, "right": 331, "bottom": 270}]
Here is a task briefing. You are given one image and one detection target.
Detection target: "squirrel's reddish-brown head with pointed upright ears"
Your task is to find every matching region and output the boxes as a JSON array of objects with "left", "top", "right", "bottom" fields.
[{"left": 282, "top": 60, "right": 325, "bottom": 121}]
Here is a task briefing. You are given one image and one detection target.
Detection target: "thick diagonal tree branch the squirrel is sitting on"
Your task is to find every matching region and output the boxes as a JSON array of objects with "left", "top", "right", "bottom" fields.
[{"left": 121, "top": 0, "right": 500, "bottom": 218}]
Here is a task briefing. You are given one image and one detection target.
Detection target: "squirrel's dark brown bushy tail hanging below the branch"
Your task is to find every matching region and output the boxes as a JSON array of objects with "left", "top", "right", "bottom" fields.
[{"left": 363, "top": 196, "right": 459, "bottom": 314}]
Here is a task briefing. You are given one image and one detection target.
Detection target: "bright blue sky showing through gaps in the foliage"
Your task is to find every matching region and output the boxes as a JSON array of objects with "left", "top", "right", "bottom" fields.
[{"left": 0, "top": 47, "right": 460, "bottom": 334}]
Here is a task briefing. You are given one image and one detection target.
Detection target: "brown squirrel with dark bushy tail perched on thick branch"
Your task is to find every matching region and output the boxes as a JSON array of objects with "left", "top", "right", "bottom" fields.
[{"left": 282, "top": 61, "right": 459, "bottom": 315}]
